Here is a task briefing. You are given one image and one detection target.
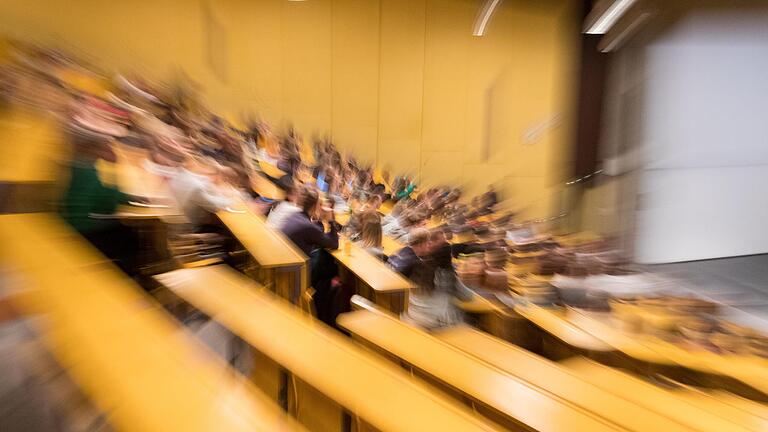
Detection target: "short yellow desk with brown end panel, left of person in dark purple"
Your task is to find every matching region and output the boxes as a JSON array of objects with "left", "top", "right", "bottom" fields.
[{"left": 217, "top": 203, "right": 309, "bottom": 303}]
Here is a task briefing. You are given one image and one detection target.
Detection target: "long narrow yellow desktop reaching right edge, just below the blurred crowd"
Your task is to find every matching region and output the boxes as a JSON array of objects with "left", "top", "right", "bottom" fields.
[{"left": 568, "top": 311, "right": 768, "bottom": 393}]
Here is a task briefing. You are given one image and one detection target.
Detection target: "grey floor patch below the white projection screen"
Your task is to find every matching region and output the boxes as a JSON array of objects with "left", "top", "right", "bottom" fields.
[{"left": 650, "top": 254, "right": 768, "bottom": 331}]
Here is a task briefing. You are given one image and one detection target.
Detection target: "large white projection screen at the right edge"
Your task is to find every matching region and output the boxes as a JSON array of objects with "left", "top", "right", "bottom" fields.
[{"left": 635, "top": 8, "right": 768, "bottom": 263}]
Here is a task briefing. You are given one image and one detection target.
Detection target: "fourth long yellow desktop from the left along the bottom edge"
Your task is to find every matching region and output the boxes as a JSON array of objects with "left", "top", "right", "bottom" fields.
[{"left": 437, "top": 326, "right": 747, "bottom": 432}]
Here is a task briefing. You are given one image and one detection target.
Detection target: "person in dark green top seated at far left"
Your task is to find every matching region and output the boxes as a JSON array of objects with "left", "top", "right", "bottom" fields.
[{"left": 59, "top": 127, "right": 139, "bottom": 275}]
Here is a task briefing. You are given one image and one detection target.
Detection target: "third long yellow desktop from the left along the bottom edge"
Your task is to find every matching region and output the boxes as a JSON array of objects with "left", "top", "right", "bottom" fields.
[{"left": 337, "top": 310, "right": 625, "bottom": 431}]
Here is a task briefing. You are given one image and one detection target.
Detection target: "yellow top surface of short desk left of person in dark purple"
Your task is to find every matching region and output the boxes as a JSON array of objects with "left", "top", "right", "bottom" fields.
[{"left": 217, "top": 203, "right": 307, "bottom": 268}]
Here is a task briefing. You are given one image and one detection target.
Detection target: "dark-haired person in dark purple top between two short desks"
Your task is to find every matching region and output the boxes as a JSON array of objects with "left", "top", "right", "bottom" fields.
[{"left": 281, "top": 186, "right": 339, "bottom": 326}]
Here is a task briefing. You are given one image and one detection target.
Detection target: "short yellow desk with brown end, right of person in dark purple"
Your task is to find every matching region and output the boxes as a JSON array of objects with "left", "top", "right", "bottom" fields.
[{"left": 331, "top": 239, "right": 416, "bottom": 314}]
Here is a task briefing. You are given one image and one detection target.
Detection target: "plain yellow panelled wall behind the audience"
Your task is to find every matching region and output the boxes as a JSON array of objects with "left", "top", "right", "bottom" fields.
[{"left": 0, "top": 0, "right": 578, "bottom": 217}]
